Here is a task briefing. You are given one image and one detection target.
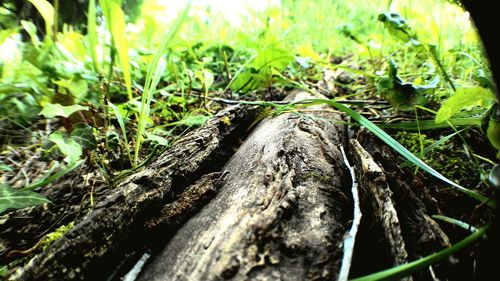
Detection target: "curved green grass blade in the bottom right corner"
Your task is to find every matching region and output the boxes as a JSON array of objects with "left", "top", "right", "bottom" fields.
[{"left": 351, "top": 225, "right": 489, "bottom": 281}]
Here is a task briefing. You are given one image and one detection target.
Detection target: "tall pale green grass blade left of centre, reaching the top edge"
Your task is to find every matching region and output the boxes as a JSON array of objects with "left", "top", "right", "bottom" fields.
[{"left": 134, "top": 0, "right": 191, "bottom": 165}]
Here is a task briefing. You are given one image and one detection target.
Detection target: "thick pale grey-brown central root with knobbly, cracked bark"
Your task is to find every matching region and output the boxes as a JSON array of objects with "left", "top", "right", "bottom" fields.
[{"left": 140, "top": 93, "right": 352, "bottom": 280}]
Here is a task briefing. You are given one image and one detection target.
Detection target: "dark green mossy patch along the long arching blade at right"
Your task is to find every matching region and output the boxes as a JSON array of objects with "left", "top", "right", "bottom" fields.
[{"left": 394, "top": 131, "right": 479, "bottom": 186}]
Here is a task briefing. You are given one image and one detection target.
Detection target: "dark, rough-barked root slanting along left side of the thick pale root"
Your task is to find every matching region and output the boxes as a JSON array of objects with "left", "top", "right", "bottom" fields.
[{"left": 8, "top": 106, "right": 258, "bottom": 280}]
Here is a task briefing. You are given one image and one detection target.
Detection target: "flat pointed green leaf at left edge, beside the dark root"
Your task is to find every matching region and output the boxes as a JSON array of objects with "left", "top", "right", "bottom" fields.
[{"left": 0, "top": 184, "right": 50, "bottom": 214}]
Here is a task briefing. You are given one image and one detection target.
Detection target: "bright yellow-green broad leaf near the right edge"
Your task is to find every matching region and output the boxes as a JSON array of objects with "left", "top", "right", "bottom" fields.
[{"left": 436, "top": 87, "right": 495, "bottom": 123}]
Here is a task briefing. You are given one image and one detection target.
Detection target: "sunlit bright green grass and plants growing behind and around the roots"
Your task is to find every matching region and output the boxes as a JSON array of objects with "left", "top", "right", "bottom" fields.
[{"left": 0, "top": 0, "right": 500, "bottom": 280}]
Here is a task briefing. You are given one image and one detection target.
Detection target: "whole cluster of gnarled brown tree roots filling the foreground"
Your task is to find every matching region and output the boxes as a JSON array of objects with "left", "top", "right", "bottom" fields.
[{"left": 6, "top": 92, "right": 453, "bottom": 280}]
